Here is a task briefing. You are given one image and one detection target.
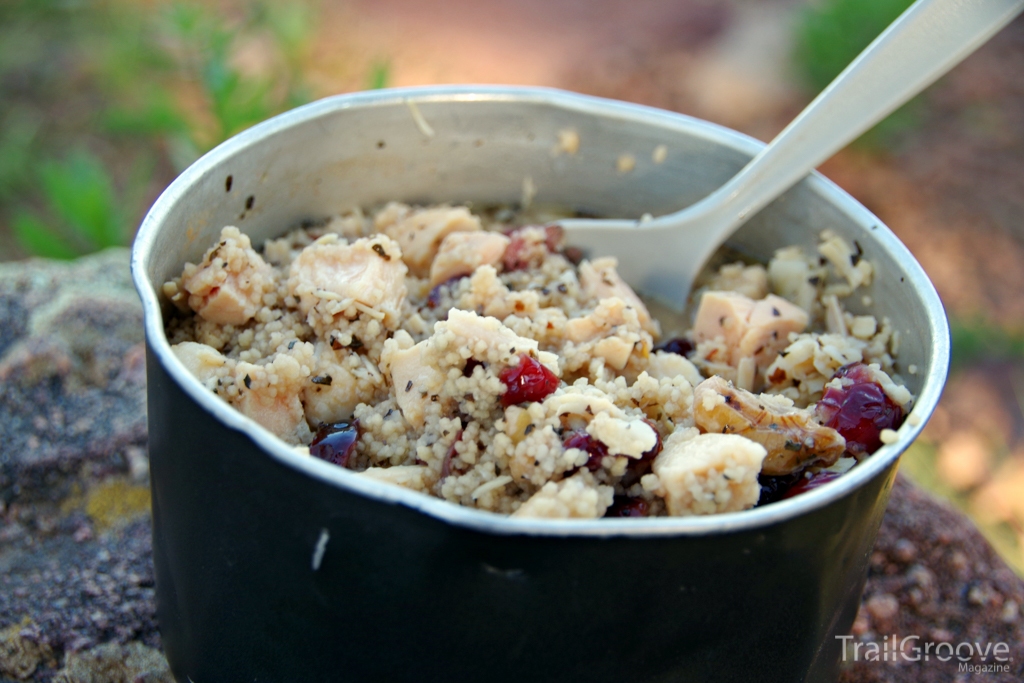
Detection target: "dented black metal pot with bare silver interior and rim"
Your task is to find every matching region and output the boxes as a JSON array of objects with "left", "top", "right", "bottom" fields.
[{"left": 132, "top": 86, "right": 949, "bottom": 683}]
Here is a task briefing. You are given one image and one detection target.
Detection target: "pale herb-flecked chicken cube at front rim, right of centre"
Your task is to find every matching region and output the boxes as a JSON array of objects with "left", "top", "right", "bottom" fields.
[{"left": 652, "top": 430, "right": 765, "bottom": 516}]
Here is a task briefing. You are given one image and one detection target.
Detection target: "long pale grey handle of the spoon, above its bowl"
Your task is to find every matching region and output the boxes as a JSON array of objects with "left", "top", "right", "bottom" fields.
[{"left": 696, "top": 0, "right": 1024, "bottom": 229}]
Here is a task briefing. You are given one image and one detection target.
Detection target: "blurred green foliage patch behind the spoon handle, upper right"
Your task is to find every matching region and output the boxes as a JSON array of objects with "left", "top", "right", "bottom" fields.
[{"left": 794, "top": 0, "right": 922, "bottom": 150}]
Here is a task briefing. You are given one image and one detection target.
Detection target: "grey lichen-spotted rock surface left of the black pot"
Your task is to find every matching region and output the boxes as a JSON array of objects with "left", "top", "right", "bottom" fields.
[{"left": 0, "top": 249, "right": 155, "bottom": 681}]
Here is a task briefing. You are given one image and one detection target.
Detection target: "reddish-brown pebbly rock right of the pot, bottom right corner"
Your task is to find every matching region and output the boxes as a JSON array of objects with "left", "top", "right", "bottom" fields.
[{"left": 840, "top": 477, "right": 1024, "bottom": 683}]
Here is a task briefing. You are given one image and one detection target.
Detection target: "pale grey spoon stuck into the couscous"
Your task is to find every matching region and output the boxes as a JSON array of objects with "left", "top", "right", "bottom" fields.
[{"left": 559, "top": 0, "right": 1024, "bottom": 310}]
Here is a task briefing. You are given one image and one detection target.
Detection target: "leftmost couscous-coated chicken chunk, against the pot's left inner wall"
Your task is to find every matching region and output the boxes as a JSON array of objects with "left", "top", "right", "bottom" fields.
[{"left": 181, "top": 226, "right": 273, "bottom": 326}]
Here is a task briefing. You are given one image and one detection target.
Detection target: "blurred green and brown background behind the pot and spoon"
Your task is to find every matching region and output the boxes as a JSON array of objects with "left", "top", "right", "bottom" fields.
[{"left": 0, "top": 0, "right": 1024, "bottom": 574}]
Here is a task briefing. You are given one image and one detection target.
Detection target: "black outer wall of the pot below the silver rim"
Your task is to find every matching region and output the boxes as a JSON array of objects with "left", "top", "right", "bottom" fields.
[{"left": 148, "top": 352, "right": 896, "bottom": 683}]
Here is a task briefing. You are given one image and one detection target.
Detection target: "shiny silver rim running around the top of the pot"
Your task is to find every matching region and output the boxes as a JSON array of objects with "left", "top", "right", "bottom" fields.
[{"left": 131, "top": 85, "right": 950, "bottom": 538}]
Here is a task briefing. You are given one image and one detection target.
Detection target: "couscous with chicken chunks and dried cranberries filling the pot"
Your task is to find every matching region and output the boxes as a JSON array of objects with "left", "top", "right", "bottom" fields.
[{"left": 164, "top": 203, "right": 912, "bottom": 518}]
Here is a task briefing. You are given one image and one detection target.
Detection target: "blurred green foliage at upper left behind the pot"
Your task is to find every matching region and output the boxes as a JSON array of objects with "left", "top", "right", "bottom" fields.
[{"left": 0, "top": 0, "right": 327, "bottom": 258}]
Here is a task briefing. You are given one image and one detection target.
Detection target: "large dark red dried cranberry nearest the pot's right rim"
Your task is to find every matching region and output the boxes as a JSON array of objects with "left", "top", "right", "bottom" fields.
[{"left": 815, "top": 362, "right": 903, "bottom": 456}]
